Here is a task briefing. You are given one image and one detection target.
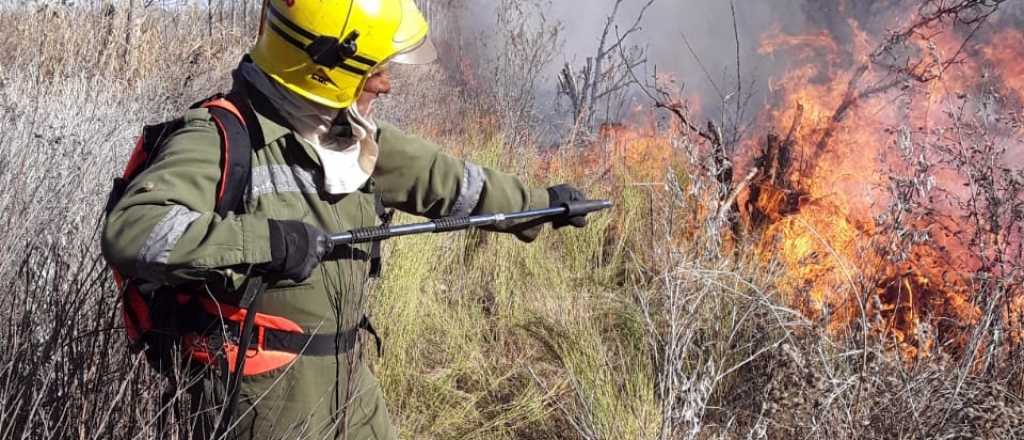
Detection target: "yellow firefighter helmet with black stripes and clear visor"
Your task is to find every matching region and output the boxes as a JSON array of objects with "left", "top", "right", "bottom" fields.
[{"left": 251, "top": 0, "right": 437, "bottom": 108}]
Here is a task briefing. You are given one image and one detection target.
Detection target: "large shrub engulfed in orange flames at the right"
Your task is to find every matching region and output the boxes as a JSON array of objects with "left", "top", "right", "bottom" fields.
[{"left": 704, "top": 1, "right": 1024, "bottom": 357}]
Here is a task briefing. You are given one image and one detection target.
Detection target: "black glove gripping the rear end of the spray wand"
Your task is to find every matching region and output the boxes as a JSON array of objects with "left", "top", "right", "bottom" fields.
[{"left": 263, "top": 220, "right": 329, "bottom": 282}]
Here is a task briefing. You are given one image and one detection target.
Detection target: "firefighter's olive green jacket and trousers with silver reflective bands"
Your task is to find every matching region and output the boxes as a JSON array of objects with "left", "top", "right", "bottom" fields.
[{"left": 102, "top": 84, "right": 549, "bottom": 439}]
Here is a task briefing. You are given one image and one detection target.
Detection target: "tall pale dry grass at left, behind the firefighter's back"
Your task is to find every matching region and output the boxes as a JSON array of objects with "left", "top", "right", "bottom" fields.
[{"left": 0, "top": 3, "right": 248, "bottom": 438}]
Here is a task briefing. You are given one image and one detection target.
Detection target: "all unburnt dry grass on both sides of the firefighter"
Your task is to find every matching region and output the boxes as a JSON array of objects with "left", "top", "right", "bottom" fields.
[{"left": 0, "top": 1, "right": 1024, "bottom": 439}]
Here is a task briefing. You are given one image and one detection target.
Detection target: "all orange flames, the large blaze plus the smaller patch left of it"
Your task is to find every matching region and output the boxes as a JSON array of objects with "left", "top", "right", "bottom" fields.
[{"left": 532, "top": 2, "right": 1024, "bottom": 359}]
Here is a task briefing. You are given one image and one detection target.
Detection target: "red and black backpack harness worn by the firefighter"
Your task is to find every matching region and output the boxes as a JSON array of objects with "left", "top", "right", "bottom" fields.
[{"left": 105, "top": 92, "right": 388, "bottom": 376}]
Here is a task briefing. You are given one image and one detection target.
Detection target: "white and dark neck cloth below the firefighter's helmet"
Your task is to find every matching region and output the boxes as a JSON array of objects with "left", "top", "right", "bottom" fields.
[{"left": 240, "top": 62, "right": 380, "bottom": 194}]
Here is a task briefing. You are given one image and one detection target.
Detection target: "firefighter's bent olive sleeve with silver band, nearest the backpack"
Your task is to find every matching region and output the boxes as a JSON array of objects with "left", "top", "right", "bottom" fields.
[{"left": 102, "top": 111, "right": 271, "bottom": 289}]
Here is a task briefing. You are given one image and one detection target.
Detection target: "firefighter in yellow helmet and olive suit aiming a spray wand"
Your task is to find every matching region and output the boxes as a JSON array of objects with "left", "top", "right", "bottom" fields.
[{"left": 102, "top": 0, "right": 586, "bottom": 439}]
